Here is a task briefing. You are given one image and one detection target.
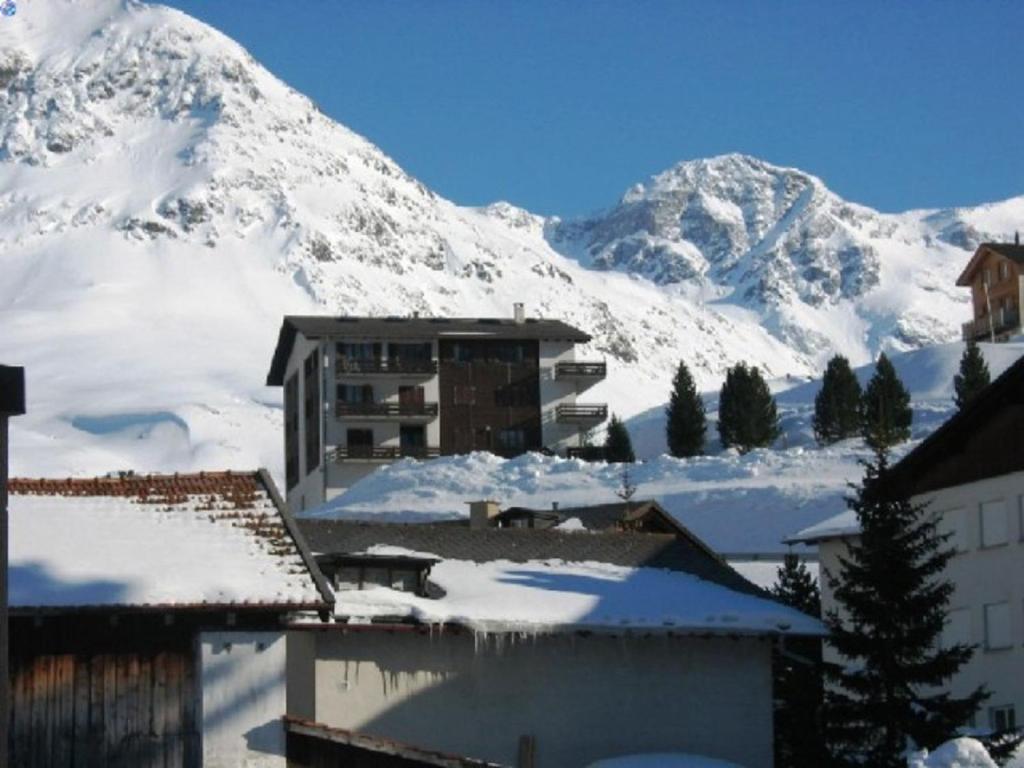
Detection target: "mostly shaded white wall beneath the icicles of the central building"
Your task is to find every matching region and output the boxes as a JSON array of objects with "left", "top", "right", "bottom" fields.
[{"left": 289, "top": 628, "right": 772, "bottom": 768}]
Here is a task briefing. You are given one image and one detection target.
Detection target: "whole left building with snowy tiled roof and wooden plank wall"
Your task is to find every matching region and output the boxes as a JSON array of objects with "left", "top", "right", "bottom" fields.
[{"left": 8, "top": 471, "right": 331, "bottom": 768}]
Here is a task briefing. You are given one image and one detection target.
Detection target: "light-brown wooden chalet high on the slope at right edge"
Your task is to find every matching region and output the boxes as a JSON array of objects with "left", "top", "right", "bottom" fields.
[{"left": 956, "top": 236, "right": 1024, "bottom": 342}]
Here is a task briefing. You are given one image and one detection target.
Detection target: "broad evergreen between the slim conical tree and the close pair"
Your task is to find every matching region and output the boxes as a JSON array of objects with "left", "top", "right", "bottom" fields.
[{"left": 718, "top": 362, "right": 781, "bottom": 454}]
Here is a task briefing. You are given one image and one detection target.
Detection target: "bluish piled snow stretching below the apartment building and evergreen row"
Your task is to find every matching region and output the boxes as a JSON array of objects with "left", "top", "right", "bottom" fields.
[{"left": 306, "top": 343, "right": 1024, "bottom": 561}]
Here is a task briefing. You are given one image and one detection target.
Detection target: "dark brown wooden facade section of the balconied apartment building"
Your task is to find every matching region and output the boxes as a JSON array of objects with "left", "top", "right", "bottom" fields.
[{"left": 438, "top": 339, "right": 542, "bottom": 456}]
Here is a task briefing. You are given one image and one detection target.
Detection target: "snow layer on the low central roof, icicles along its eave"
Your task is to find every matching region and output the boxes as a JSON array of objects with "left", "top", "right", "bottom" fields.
[{"left": 335, "top": 546, "right": 822, "bottom": 635}]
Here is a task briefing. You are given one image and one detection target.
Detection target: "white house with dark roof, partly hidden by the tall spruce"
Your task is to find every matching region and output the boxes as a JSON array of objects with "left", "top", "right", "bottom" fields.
[{"left": 791, "top": 358, "right": 1024, "bottom": 730}]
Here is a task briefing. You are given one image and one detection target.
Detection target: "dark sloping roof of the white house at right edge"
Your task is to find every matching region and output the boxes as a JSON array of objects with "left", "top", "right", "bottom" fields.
[{"left": 880, "top": 357, "right": 1024, "bottom": 496}]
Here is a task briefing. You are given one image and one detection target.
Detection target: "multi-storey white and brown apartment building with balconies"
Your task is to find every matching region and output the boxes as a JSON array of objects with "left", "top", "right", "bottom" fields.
[{"left": 267, "top": 305, "right": 608, "bottom": 512}]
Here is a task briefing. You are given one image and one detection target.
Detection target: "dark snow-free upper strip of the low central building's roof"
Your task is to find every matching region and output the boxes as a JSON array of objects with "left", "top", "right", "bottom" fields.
[{"left": 298, "top": 519, "right": 764, "bottom": 597}]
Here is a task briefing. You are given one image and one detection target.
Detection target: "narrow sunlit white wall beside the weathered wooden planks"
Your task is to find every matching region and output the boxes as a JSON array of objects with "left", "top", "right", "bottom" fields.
[{"left": 200, "top": 631, "right": 287, "bottom": 768}]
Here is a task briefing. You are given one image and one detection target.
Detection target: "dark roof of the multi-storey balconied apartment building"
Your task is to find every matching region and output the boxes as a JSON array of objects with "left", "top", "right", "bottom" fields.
[{"left": 266, "top": 314, "right": 591, "bottom": 386}]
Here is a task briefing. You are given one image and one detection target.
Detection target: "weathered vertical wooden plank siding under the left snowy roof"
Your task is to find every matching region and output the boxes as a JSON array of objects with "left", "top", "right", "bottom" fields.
[{"left": 9, "top": 649, "right": 200, "bottom": 768}]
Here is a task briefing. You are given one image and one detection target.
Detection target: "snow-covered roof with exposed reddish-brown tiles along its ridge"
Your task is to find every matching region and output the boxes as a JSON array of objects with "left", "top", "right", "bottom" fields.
[{"left": 8, "top": 471, "right": 331, "bottom": 609}]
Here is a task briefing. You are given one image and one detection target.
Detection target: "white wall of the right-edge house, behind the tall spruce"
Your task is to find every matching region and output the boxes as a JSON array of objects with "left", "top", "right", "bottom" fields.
[{"left": 818, "top": 472, "right": 1024, "bottom": 728}]
